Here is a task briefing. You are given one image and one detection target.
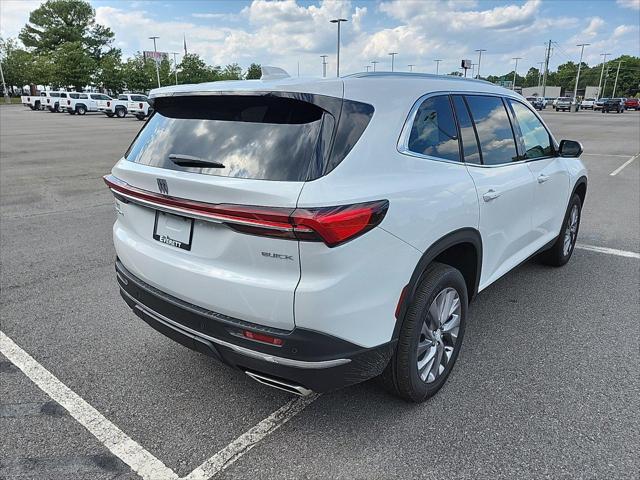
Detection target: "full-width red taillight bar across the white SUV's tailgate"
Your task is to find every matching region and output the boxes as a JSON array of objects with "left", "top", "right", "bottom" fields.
[{"left": 104, "top": 175, "right": 389, "bottom": 247}]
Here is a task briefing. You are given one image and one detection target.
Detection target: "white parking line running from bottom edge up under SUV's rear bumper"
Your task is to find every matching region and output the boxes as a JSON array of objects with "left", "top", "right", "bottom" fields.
[{"left": 184, "top": 394, "right": 320, "bottom": 480}]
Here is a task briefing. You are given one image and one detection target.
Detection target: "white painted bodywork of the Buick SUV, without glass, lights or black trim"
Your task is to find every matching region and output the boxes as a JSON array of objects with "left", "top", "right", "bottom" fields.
[{"left": 112, "top": 75, "right": 586, "bottom": 347}]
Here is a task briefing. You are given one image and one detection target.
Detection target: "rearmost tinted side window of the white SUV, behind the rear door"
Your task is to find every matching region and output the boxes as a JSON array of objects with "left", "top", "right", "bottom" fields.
[{"left": 407, "top": 95, "right": 460, "bottom": 161}]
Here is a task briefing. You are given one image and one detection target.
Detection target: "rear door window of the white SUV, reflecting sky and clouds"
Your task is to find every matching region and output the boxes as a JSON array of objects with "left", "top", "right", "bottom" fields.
[{"left": 465, "top": 95, "right": 518, "bottom": 165}]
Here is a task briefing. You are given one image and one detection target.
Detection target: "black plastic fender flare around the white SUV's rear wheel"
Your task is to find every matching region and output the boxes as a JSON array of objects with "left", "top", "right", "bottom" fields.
[{"left": 392, "top": 228, "right": 482, "bottom": 340}]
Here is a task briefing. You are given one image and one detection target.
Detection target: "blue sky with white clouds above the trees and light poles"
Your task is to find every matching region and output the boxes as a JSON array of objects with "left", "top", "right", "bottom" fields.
[{"left": 0, "top": 0, "right": 640, "bottom": 75}]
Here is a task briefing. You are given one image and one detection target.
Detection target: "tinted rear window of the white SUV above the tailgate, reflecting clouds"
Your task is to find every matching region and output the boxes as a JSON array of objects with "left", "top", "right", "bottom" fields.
[{"left": 125, "top": 94, "right": 373, "bottom": 181}]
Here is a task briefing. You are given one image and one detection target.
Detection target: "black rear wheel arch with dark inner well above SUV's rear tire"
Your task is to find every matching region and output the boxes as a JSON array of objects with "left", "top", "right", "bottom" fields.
[{"left": 393, "top": 228, "right": 482, "bottom": 339}]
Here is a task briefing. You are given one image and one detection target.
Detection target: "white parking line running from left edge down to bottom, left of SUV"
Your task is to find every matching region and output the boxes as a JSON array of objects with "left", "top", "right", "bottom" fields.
[{"left": 0, "top": 331, "right": 178, "bottom": 480}]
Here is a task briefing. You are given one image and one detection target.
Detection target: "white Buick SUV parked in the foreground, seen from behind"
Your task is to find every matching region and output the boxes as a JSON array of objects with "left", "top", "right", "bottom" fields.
[{"left": 104, "top": 73, "right": 587, "bottom": 402}]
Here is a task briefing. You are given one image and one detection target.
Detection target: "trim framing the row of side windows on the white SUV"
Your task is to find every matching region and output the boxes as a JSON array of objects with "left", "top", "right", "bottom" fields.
[{"left": 396, "top": 90, "right": 558, "bottom": 168}]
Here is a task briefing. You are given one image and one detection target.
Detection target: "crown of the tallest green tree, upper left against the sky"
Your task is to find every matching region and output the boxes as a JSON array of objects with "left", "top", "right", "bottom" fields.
[{"left": 18, "top": 0, "right": 113, "bottom": 60}]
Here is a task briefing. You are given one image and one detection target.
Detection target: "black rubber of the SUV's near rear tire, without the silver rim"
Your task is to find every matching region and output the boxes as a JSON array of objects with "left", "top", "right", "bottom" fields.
[{"left": 380, "top": 262, "right": 469, "bottom": 403}]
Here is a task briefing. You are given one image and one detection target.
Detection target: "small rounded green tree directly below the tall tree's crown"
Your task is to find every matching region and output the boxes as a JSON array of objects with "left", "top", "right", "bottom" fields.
[{"left": 52, "top": 41, "right": 96, "bottom": 92}]
